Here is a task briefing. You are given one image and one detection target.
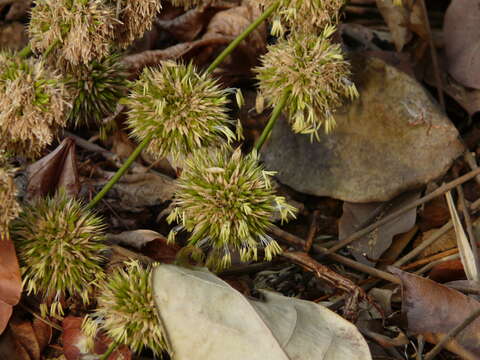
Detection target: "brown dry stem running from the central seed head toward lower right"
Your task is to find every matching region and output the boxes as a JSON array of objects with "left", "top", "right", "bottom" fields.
[{"left": 269, "top": 226, "right": 401, "bottom": 284}]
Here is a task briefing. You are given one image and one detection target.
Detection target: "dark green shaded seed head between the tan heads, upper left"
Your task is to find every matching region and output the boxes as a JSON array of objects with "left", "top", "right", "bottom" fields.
[{"left": 67, "top": 56, "right": 128, "bottom": 126}]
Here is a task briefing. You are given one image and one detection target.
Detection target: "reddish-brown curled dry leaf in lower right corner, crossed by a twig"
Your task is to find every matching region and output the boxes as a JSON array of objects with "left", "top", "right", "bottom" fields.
[{"left": 390, "top": 268, "right": 480, "bottom": 359}]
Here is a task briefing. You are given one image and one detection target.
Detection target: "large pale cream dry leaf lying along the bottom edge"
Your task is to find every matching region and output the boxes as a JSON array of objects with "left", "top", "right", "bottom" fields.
[{"left": 152, "top": 265, "right": 371, "bottom": 360}]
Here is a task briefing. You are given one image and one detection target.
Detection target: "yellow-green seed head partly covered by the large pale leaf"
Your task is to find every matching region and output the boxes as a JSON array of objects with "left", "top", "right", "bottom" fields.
[{"left": 83, "top": 261, "right": 167, "bottom": 355}]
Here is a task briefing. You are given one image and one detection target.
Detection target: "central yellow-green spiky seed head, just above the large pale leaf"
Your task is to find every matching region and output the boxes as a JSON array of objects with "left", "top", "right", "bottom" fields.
[{"left": 168, "top": 148, "right": 295, "bottom": 270}]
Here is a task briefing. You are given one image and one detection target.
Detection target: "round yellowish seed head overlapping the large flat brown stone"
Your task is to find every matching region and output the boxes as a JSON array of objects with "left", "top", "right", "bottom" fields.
[{"left": 255, "top": 26, "right": 358, "bottom": 138}]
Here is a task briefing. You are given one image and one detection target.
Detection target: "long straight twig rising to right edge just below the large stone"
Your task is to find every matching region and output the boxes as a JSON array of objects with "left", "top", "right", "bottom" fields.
[{"left": 326, "top": 168, "right": 480, "bottom": 255}]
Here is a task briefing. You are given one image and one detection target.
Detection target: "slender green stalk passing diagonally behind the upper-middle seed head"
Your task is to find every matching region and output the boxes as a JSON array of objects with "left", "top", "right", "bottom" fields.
[{"left": 88, "top": 1, "right": 283, "bottom": 208}]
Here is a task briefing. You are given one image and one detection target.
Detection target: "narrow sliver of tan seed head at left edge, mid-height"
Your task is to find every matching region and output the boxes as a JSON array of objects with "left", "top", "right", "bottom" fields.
[{"left": 0, "top": 151, "right": 20, "bottom": 241}]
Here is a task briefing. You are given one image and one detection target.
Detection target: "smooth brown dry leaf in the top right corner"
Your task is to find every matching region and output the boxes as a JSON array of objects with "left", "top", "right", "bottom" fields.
[{"left": 443, "top": 0, "right": 480, "bottom": 89}]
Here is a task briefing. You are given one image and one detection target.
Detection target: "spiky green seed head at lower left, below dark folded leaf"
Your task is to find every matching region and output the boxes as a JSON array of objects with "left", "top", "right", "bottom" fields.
[{"left": 12, "top": 191, "right": 106, "bottom": 316}]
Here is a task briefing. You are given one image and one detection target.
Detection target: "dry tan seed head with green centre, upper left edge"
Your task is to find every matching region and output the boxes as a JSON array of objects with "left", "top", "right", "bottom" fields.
[{"left": 0, "top": 52, "right": 66, "bottom": 158}]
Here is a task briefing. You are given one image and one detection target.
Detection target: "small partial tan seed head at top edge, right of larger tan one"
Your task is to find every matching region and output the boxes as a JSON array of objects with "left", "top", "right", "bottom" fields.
[{"left": 114, "top": 0, "right": 162, "bottom": 48}]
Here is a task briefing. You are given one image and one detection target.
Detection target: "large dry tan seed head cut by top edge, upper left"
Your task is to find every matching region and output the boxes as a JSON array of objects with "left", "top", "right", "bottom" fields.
[{"left": 28, "top": 0, "right": 119, "bottom": 69}]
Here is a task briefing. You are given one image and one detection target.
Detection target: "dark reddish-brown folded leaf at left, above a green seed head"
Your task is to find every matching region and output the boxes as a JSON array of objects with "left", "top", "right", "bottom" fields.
[{"left": 26, "top": 138, "right": 80, "bottom": 200}]
